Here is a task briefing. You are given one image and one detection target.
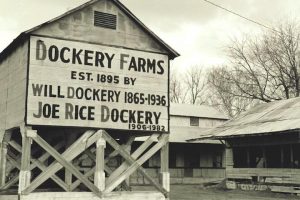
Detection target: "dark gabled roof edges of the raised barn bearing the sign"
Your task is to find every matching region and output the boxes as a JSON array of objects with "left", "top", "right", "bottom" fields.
[{"left": 0, "top": 0, "right": 180, "bottom": 63}]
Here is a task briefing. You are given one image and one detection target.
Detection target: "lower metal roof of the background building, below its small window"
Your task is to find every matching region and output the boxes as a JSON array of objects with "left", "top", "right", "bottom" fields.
[{"left": 136, "top": 126, "right": 221, "bottom": 144}]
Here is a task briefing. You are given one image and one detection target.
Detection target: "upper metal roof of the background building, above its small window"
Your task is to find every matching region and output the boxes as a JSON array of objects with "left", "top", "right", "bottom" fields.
[{"left": 170, "top": 103, "right": 229, "bottom": 120}]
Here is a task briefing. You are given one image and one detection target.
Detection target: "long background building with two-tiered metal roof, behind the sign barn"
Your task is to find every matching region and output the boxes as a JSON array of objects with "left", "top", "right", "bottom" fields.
[{"left": 131, "top": 104, "right": 228, "bottom": 184}]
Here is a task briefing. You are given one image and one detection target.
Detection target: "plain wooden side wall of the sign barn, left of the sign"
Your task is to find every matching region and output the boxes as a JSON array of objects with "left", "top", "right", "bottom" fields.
[{"left": 0, "top": 42, "right": 28, "bottom": 131}]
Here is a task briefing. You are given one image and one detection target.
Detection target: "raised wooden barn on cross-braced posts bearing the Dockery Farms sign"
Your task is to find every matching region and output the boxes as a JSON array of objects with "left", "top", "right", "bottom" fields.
[{"left": 0, "top": 0, "right": 179, "bottom": 200}]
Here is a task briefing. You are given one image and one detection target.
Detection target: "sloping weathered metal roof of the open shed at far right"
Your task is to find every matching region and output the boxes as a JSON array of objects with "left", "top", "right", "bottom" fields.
[{"left": 190, "top": 97, "right": 300, "bottom": 140}]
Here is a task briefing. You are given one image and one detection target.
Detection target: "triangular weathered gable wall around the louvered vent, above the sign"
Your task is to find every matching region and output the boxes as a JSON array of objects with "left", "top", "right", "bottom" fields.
[{"left": 33, "top": 0, "right": 167, "bottom": 53}]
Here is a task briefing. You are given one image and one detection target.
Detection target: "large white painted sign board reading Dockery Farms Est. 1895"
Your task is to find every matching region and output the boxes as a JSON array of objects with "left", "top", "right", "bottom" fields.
[{"left": 27, "top": 36, "right": 169, "bottom": 131}]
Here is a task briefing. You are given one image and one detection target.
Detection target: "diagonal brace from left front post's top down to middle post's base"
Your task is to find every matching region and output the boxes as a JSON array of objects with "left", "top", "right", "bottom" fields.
[{"left": 32, "top": 135, "right": 102, "bottom": 198}]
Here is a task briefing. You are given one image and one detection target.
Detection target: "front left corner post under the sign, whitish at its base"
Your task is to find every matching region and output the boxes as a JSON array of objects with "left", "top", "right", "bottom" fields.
[{"left": 18, "top": 126, "right": 36, "bottom": 194}]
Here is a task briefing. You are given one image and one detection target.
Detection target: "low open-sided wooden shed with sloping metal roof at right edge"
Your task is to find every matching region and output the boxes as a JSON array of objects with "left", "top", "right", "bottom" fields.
[{"left": 191, "top": 98, "right": 300, "bottom": 193}]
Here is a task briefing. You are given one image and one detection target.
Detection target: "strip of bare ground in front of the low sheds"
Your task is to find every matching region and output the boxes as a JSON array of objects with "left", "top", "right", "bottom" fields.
[{"left": 134, "top": 185, "right": 300, "bottom": 200}]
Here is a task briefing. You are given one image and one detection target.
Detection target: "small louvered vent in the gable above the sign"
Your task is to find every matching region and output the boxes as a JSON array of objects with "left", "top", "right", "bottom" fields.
[{"left": 94, "top": 11, "right": 117, "bottom": 29}]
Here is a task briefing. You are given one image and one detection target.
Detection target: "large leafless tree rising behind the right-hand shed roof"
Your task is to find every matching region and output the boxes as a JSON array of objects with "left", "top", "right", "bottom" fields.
[{"left": 209, "top": 23, "right": 300, "bottom": 116}]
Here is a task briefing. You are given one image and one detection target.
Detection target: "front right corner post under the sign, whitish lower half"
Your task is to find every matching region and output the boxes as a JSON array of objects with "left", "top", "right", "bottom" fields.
[{"left": 160, "top": 135, "right": 170, "bottom": 192}]
